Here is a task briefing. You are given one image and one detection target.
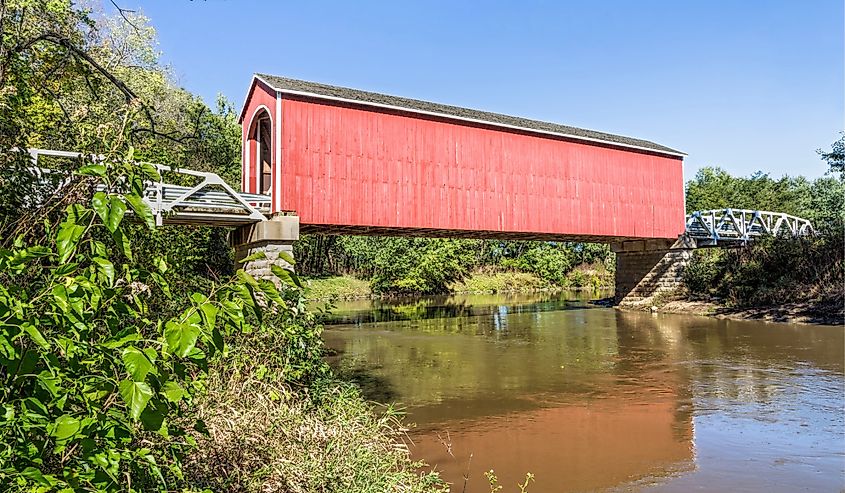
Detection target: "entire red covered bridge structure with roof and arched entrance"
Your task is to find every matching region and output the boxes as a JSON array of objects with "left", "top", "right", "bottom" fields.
[{"left": 240, "top": 75, "right": 684, "bottom": 243}]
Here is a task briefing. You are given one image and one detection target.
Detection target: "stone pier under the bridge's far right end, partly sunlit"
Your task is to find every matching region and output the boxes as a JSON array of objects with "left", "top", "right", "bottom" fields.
[{"left": 611, "top": 235, "right": 696, "bottom": 308}]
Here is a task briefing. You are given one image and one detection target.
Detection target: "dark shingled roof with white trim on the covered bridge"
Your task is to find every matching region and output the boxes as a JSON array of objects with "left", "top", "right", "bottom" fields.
[{"left": 255, "top": 74, "right": 685, "bottom": 156}]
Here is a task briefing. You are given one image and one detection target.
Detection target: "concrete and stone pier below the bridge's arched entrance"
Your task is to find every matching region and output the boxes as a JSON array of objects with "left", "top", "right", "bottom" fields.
[{"left": 231, "top": 214, "right": 299, "bottom": 282}]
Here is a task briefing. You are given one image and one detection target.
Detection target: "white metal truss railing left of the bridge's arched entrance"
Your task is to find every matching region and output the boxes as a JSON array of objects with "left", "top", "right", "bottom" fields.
[{"left": 28, "top": 149, "right": 271, "bottom": 226}]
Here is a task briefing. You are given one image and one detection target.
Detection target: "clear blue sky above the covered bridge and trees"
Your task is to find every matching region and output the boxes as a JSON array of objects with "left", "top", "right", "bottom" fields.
[{"left": 115, "top": 0, "right": 845, "bottom": 178}]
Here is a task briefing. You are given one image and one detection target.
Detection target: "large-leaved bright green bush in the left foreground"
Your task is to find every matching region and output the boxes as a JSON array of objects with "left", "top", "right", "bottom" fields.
[{"left": 0, "top": 154, "right": 304, "bottom": 491}]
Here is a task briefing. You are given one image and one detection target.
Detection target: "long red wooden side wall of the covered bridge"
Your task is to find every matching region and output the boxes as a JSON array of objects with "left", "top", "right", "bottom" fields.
[{"left": 278, "top": 94, "right": 684, "bottom": 240}]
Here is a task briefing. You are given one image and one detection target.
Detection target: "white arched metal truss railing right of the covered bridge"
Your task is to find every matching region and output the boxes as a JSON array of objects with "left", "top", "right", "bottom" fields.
[{"left": 686, "top": 209, "right": 814, "bottom": 246}]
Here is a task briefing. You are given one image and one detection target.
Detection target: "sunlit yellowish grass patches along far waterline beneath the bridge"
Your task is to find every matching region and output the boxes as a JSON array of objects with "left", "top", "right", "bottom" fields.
[{"left": 303, "top": 266, "right": 613, "bottom": 301}]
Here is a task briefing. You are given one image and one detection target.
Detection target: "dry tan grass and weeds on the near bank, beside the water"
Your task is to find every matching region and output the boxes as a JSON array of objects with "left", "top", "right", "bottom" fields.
[{"left": 185, "top": 374, "right": 443, "bottom": 493}]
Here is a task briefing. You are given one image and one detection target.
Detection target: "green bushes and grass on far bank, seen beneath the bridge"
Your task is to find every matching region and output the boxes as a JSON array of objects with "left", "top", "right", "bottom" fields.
[{"left": 295, "top": 235, "right": 615, "bottom": 298}]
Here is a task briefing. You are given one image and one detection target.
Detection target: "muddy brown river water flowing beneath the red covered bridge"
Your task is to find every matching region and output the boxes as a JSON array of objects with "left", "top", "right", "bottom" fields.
[{"left": 324, "top": 293, "right": 845, "bottom": 493}]
